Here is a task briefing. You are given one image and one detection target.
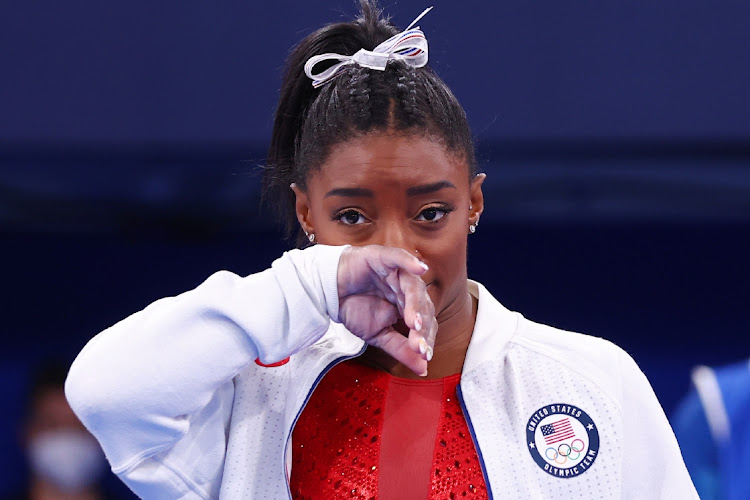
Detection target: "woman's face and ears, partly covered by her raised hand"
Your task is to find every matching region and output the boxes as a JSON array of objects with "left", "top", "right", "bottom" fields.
[{"left": 294, "top": 132, "right": 484, "bottom": 328}]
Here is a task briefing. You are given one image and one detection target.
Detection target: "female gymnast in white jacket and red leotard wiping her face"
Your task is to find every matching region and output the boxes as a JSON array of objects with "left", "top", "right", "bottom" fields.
[{"left": 66, "top": 0, "right": 697, "bottom": 499}]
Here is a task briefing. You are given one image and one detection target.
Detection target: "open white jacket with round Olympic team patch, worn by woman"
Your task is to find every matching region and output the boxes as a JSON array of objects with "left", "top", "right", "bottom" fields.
[{"left": 66, "top": 245, "right": 697, "bottom": 499}]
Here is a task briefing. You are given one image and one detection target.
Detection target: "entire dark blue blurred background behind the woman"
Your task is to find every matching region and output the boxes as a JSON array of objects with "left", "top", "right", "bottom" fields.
[{"left": 0, "top": 0, "right": 750, "bottom": 493}]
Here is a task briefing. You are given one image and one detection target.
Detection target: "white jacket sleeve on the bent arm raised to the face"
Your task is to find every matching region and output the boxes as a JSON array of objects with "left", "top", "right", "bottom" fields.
[{"left": 65, "top": 245, "right": 345, "bottom": 498}]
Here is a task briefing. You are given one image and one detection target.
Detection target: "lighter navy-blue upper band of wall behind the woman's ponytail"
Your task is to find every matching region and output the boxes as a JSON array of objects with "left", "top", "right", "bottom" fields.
[{"left": 0, "top": 0, "right": 750, "bottom": 144}]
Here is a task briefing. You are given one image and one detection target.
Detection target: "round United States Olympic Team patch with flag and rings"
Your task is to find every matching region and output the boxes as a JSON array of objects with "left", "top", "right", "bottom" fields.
[{"left": 526, "top": 404, "right": 599, "bottom": 478}]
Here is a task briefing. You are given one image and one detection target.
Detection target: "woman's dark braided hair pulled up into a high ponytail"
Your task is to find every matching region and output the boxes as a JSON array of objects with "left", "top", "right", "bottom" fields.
[{"left": 263, "top": 0, "right": 476, "bottom": 244}]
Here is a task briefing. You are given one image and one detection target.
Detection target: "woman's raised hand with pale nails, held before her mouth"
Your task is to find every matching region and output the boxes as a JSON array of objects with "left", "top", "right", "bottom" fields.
[{"left": 338, "top": 245, "right": 437, "bottom": 376}]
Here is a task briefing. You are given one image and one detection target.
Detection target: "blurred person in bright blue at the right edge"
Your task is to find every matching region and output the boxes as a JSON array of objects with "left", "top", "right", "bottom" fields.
[{"left": 672, "top": 359, "right": 750, "bottom": 500}]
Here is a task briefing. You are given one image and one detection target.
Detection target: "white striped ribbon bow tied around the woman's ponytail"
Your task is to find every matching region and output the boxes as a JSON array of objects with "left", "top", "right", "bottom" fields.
[{"left": 305, "top": 7, "right": 432, "bottom": 88}]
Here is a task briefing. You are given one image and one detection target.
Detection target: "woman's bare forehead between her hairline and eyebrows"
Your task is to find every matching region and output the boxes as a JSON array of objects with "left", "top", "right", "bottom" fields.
[{"left": 310, "top": 133, "right": 468, "bottom": 187}]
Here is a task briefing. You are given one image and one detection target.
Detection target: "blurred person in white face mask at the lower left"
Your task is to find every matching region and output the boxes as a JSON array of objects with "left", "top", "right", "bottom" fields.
[{"left": 4, "top": 361, "right": 107, "bottom": 500}]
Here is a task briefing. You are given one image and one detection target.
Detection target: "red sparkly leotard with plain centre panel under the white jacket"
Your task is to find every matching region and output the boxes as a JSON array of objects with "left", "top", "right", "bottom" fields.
[{"left": 290, "top": 361, "right": 487, "bottom": 500}]
